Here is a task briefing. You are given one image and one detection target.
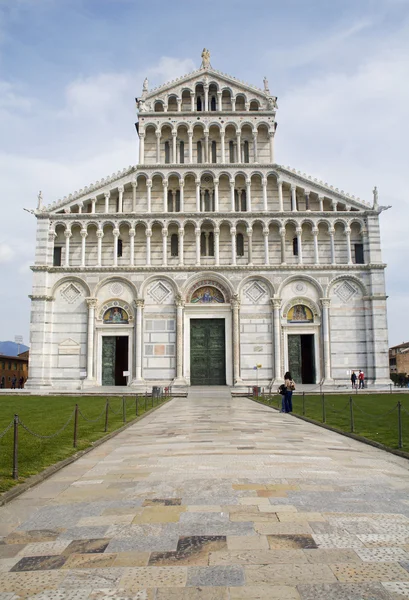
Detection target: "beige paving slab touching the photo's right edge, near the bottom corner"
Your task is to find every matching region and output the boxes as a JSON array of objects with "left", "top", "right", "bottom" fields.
[{"left": 330, "top": 562, "right": 409, "bottom": 583}]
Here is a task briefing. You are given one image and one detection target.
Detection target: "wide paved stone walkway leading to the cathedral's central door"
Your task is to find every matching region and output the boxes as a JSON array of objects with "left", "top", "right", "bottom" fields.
[{"left": 0, "top": 388, "right": 409, "bottom": 600}]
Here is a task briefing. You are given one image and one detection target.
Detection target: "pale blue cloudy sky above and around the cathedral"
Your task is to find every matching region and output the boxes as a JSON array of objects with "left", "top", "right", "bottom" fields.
[{"left": 0, "top": 0, "right": 409, "bottom": 345}]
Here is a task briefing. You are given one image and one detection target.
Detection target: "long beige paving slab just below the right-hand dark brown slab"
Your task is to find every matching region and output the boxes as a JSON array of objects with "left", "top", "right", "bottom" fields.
[{"left": 209, "top": 550, "right": 307, "bottom": 565}]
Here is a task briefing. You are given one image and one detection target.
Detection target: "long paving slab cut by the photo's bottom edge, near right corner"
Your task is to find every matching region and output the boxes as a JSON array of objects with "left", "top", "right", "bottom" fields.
[{"left": 297, "top": 583, "right": 391, "bottom": 600}]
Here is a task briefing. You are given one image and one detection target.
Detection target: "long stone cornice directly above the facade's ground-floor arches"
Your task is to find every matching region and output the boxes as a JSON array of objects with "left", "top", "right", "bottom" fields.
[{"left": 30, "top": 263, "right": 386, "bottom": 274}]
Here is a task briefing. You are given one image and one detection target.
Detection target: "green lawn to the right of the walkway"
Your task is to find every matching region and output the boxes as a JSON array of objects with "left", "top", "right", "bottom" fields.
[{"left": 261, "top": 393, "right": 409, "bottom": 452}]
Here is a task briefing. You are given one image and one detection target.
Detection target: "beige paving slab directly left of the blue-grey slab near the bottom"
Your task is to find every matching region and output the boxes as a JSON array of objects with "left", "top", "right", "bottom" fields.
[{"left": 118, "top": 567, "right": 188, "bottom": 590}]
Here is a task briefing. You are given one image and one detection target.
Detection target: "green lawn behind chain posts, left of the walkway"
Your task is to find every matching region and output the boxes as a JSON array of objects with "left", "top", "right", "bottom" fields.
[{"left": 0, "top": 395, "right": 164, "bottom": 492}]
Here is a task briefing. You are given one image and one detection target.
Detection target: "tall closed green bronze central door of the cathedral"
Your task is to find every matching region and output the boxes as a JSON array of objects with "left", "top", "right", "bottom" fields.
[{"left": 190, "top": 319, "right": 226, "bottom": 385}]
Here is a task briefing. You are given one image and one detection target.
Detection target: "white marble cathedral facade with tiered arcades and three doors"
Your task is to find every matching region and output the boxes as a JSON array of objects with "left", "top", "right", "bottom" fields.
[{"left": 28, "top": 50, "right": 389, "bottom": 389}]
